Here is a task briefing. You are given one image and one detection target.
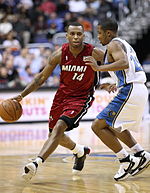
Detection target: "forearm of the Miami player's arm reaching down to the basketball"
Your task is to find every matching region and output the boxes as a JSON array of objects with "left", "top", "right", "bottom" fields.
[{"left": 21, "top": 74, "right": 45, "bottom": 97}]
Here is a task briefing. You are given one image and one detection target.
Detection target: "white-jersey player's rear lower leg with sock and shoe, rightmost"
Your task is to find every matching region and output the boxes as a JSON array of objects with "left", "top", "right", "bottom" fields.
[{"left": 112, "top": 130, "right": 150, "bottom": 176}]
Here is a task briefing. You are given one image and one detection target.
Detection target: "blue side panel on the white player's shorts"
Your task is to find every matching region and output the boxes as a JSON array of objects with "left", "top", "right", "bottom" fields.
[{"left": 96, "top": 83, "right": 133, "bottom": 127}]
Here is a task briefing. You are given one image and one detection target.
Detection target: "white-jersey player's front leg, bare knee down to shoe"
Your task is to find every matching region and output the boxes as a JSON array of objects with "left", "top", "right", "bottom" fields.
[{"left": 92, "top": 119, "right": 140, "bottom": 180}]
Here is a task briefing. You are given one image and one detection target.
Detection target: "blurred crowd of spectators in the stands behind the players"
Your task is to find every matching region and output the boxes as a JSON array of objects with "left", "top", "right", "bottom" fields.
[{"left": 0, "top": 0, "right": 130, "bottom": 88}]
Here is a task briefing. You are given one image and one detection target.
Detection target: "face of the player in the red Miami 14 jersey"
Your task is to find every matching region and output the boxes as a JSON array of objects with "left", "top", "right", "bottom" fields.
[{"left": 66, "top": 25, "right": 84, "bottom": 48}]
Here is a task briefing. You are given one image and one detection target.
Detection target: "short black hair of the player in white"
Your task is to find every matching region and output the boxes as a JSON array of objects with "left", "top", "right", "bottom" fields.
[{"left": 98, "top": 18, "right": 118, "bottom": 32}]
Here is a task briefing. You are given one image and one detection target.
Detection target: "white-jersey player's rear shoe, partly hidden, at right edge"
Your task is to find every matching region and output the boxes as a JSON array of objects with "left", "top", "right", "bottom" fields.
[{"left": 130, "top": 151, "right": 150, "bottom": 176}]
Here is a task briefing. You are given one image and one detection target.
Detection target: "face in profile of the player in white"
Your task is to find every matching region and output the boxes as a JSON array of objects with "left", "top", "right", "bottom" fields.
[{"left": 97, "top": 25, "right": 109, "bottom": 46}]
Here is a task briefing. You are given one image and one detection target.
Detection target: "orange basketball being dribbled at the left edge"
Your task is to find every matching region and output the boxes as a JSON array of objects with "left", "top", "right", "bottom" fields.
[{"left": 0, "top": 99, "right": 22, "bottom": 123}]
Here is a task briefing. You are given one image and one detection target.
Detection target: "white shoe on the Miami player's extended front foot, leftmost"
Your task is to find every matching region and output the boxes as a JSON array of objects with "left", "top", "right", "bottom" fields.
[{"left": 22, "top": 162, "right": 37, "bottom": 181}]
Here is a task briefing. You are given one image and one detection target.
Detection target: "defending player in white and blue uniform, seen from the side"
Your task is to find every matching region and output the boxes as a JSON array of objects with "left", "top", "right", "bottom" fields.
[{"left": 85, "top": 19, "right": 150, "bottom": 180}]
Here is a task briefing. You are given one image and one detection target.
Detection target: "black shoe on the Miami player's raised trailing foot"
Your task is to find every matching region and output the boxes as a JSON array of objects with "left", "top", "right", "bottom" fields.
[{"left": 72, "top": 147, "right": 91, "bottom": 174}]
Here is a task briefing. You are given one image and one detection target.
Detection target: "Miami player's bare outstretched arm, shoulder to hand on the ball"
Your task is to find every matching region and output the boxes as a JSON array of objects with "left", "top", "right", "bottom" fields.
[{"left": 13, "top": 48, "right": 61, "bottom": 101}]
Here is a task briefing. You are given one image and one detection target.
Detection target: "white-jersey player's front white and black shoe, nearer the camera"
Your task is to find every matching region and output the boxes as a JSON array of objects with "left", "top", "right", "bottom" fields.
[{"left": 114, "top": 155, "right": 140, "bottom": 181}]
